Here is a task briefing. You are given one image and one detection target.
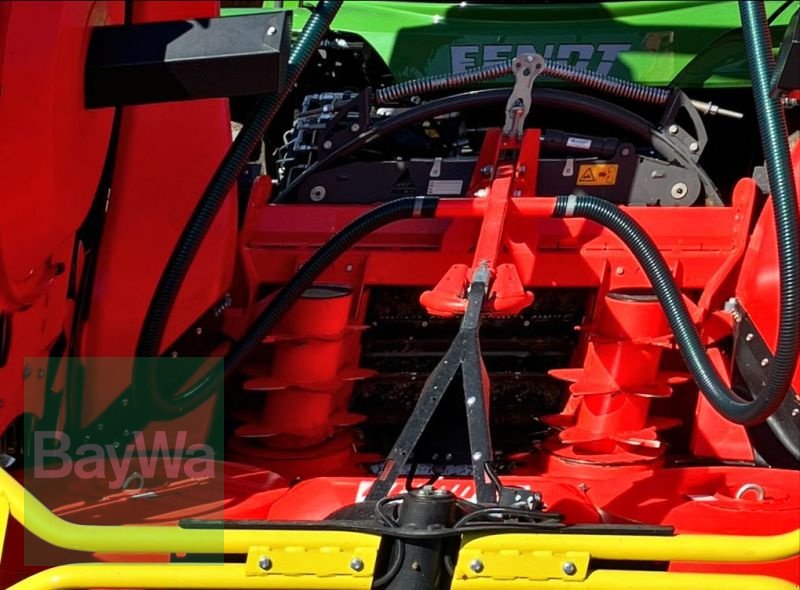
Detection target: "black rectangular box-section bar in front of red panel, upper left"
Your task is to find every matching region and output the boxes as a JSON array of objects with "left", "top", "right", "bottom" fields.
[{"left": 85, "top": 11, "right": 291, "bottom": 108}]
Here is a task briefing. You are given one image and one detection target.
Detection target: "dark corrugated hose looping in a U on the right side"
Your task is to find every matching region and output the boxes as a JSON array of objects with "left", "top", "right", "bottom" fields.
[{"left": 554, "top": 0, "right": 800, "bottom": 425}]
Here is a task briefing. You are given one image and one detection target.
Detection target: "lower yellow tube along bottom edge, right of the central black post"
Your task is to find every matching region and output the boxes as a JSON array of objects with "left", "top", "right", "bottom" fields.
[{"left": 450, "top": 570, "right": 797, "bottom": 590}]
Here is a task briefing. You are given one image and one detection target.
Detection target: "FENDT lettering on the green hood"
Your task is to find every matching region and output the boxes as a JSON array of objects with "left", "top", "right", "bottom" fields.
[{"left": 450, "top": 43, "right": 632, "bottom": 76}]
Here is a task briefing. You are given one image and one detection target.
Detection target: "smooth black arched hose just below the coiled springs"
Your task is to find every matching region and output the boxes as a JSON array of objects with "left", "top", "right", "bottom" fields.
[{"left": 272, "top": 88, "right": 722, "bottom": 205}]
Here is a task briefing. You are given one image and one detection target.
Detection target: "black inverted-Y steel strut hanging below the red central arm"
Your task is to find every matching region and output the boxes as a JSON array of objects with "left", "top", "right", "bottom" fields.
[{"left": 367, "top": 264, "right": 499, "bottom": 504}]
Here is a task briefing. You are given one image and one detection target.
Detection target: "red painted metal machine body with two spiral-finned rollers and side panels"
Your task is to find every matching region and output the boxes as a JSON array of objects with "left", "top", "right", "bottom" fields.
[{"left": 0, "top": 1, "right": 800, "bottom": 583}]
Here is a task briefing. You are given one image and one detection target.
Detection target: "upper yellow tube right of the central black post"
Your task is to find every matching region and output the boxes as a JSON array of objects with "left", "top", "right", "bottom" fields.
[{"left": 461, "top": 530, "right": 800, "bottom": 563}]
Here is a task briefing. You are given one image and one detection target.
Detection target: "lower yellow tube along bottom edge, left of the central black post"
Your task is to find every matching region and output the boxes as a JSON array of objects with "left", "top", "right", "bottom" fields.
[{"left": 8, "top": 563, "right": 372, "bottom": 590}]
